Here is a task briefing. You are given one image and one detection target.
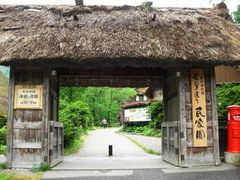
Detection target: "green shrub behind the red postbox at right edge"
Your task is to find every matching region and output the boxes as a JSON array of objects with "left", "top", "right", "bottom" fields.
[{"left": 217, "top": 83, "right": 240, "bottom": 119}]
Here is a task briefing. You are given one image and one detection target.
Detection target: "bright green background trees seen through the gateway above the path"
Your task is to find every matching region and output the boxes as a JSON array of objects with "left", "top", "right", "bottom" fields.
[{"left": 60, "top": 87, "right": 136, "bottom": 126}]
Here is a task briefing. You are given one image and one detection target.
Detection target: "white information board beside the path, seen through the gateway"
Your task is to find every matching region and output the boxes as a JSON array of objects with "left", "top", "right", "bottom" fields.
[{"left": 124, "top": 107, "right": 151, "bottom": 122}]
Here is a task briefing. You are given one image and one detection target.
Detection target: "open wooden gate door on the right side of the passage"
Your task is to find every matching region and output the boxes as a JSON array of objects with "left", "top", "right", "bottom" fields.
[{"left": 162, "top": 73, "right": 180, "bottom": 166}]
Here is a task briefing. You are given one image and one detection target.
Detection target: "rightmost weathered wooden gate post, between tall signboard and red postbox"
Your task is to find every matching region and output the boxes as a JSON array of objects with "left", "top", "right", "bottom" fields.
[{"left": 210, "top": 68, "right": 221, "bottom": 165}]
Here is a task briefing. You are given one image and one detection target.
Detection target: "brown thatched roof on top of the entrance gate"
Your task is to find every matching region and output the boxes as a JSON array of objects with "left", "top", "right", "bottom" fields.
[{"left": 0, "top": 6, "right": 240, "bottom": 67}]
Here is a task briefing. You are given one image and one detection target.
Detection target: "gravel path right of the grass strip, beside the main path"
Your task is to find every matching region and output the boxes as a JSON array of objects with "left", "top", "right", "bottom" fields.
[{"left": 123, "top": 133, "right": 162, "bottom": 153}]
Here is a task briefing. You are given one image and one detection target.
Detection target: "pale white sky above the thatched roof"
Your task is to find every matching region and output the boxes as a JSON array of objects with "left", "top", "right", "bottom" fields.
[{"left": 0, "top": 0, "right": 240, "bottom": 12}]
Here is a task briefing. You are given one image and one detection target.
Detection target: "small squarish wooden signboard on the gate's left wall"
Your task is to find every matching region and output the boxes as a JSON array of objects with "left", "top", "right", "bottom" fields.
[{"left": 14, "top": 85, "right": 43, "bottom": 109}]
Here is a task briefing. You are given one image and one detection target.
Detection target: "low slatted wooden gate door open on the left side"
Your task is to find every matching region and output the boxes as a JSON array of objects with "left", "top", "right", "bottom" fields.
[{"left": 49, "top": 121, "right": 64, "bottom": 167}]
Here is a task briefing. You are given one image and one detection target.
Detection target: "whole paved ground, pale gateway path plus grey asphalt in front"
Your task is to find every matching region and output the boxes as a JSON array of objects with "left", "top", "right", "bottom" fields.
[{"left": 42, "top": 128, "right": 240, "bottom": 180}]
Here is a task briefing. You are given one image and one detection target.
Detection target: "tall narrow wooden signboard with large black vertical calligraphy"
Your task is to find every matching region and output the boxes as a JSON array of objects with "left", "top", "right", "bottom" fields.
[{"left": 191, "top": 69, "right": 207, "bottom": 147}]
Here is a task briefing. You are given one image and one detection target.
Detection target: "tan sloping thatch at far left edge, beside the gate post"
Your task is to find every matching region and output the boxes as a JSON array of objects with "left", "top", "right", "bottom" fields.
[{"left": 0, "top": 71, "right": 8, "bottom": 115}]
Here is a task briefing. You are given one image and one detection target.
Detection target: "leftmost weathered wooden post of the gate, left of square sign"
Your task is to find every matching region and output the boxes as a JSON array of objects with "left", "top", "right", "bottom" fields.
[{"left": 7, "top": 67, "right": 15, "bottom": 168}]
